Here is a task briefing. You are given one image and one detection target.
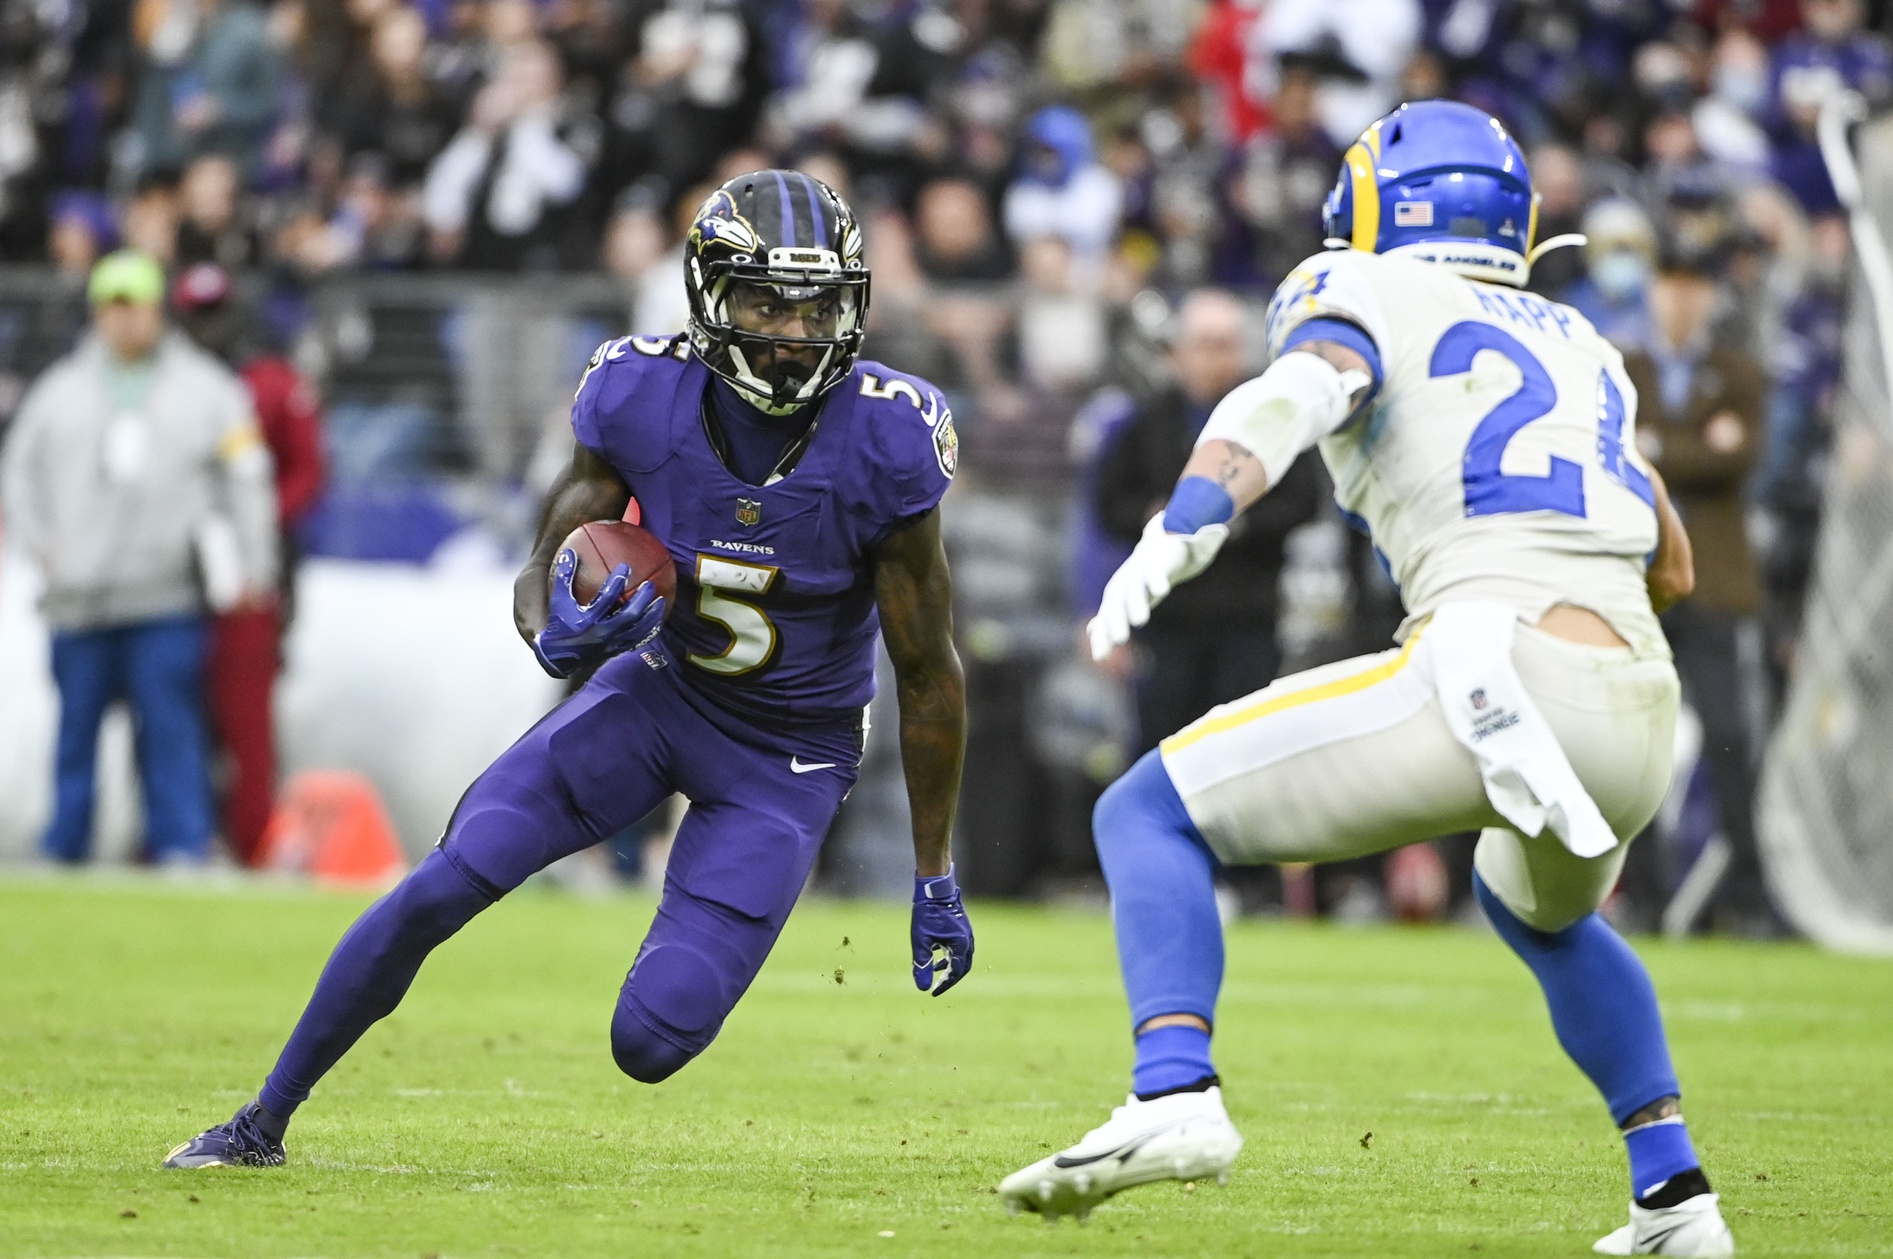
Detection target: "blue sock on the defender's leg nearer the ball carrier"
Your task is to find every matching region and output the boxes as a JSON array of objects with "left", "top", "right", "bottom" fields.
[{"left": 1092, "top": 752, "right": 1223, "bottom": 1092}]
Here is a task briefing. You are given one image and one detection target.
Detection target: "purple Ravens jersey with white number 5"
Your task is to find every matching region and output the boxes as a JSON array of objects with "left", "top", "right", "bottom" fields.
[{"left": 556, "top": 337, "right": 958, "bottom": 723}]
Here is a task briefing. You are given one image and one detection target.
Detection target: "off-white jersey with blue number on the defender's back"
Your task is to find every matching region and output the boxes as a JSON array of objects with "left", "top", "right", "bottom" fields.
[{"left": 1268, "top": 250, "right": 1668, "bottom": 655}]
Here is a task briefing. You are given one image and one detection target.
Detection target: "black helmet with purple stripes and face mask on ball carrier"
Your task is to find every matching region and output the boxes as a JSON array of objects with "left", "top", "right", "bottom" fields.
[{"left": 683, "top": 170, "right": 869, "bottom": 415}]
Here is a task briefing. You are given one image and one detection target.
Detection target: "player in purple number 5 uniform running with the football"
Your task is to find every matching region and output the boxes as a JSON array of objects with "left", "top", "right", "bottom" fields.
[{"left": 165, "top": 170, "right": 973, "bottom": 1168}]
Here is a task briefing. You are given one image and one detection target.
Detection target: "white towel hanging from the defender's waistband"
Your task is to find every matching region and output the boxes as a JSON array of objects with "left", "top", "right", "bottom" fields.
[{"left": 1422, "top": 600, "right": 1617, "bottom": 858}]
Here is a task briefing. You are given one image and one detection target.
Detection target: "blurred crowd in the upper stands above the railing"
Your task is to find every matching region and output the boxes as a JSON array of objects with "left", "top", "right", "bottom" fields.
[{"left": 0, "top": 0, "right": 1893, "bottom": 299}]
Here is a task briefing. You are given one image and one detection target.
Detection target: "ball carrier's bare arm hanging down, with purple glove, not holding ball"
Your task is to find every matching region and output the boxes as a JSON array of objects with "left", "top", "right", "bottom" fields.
[{"left": 875, "top": 507, "right": 973, "bottom": 996}]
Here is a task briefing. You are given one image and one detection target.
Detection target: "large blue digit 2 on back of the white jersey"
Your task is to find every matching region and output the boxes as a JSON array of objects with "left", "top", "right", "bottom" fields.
[{"left": 1427, "top": 320, "right": 1582, "bottom": 517}]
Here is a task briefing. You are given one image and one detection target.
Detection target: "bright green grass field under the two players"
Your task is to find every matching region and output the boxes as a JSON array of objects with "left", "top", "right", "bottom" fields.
[{"left": 0, "top": 880, "right": 1893, "bottom": 1259}]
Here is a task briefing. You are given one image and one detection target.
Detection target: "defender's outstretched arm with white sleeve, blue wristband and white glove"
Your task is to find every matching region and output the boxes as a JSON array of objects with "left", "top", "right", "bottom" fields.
[{"left": 1087, "top": 341, "right": 1376, "bottom": 661}]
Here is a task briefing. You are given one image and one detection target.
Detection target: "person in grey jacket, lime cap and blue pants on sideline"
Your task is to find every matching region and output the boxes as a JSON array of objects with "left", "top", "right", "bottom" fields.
[{"left": 0, "top": 250, "right": 276, "bottom": 863}]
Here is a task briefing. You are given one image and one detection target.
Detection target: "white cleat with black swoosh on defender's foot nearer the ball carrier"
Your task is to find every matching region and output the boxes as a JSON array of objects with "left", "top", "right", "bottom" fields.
[{"left": 1000, "top": 1087, "right": 1242, "bottom": 1221}]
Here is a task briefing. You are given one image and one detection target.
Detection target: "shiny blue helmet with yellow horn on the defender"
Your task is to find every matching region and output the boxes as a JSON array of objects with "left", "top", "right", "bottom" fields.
[{"left": 1321, "top": 100, "right": 1583, "bottom": 288}]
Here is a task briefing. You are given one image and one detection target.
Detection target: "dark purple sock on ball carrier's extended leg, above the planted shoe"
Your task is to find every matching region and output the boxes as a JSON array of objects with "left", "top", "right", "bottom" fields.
[{"left": 257, "top": 848, "right": 498, "bottom": 1125}]
